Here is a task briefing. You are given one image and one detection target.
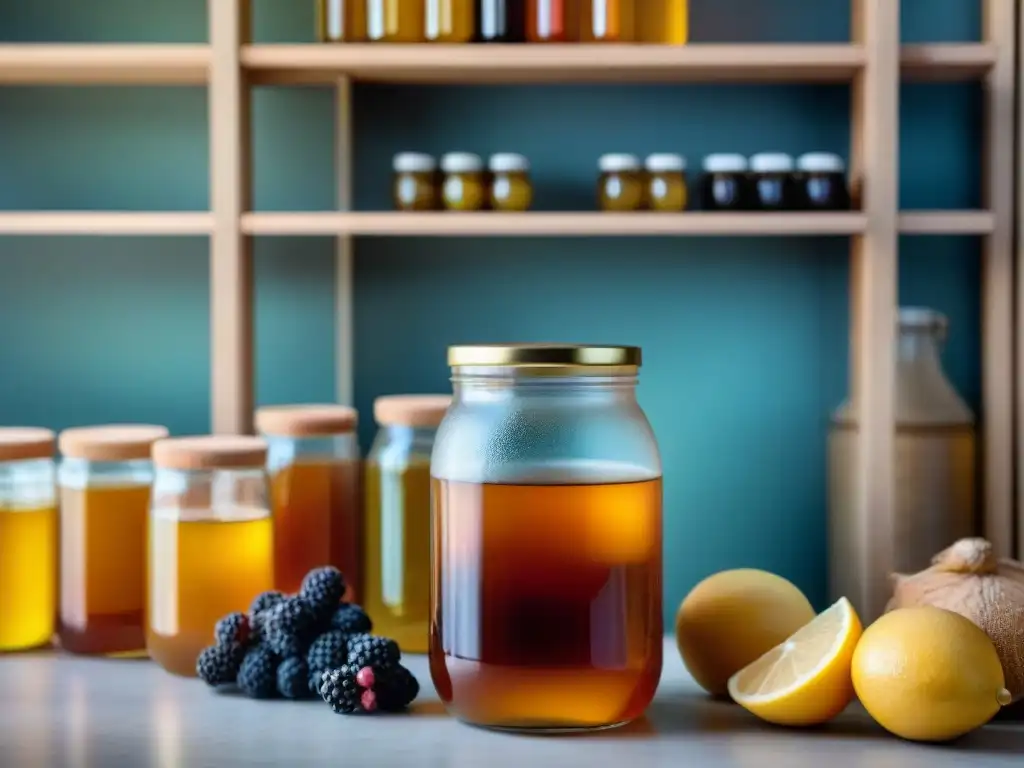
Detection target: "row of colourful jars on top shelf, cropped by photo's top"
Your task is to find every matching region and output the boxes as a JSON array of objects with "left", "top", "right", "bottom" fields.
[{"left": 316, "top": 0, "right": 689, "bottom": 45}]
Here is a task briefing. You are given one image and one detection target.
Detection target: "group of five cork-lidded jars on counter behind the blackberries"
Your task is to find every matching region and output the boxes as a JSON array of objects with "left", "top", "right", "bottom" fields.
[{"left": 0, "top": 395, "right": 451, "bottom": 676}]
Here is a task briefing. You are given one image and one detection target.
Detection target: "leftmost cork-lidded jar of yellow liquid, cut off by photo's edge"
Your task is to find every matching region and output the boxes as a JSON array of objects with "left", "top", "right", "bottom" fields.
[{"left": 0, "top": 427, "right": 57, "bottom": 653}]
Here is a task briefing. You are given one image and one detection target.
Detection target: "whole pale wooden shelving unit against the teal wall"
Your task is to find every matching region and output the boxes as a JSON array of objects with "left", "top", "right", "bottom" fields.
[{"left": 0, "top": 0, "right": 1024, "bottom": 589}]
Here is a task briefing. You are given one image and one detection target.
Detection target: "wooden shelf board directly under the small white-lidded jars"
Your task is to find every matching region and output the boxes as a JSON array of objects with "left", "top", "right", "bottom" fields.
[{"left": 242, "top": 211, "right": 865, "bottom": 238}]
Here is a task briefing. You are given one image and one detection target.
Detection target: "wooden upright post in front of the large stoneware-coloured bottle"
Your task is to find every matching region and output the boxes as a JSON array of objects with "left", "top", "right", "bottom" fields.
[{"left": 849, "top": 0, "right": 900, "bottom": 622}]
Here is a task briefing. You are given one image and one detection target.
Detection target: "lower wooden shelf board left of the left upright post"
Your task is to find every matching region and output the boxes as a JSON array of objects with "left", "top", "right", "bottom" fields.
[{"left": 0, "top": 211, "right": 213, "bottom": 236}]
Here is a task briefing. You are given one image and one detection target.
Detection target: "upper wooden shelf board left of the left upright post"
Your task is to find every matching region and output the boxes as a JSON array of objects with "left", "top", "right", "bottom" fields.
[{"left": 0, "top": 43, "right": 210, "bottom": 85}]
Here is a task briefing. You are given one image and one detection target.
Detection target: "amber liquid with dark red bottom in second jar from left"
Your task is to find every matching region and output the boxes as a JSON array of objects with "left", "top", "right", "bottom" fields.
[{"left": 57, "top": 484, "right": 150, "bottom": 654}]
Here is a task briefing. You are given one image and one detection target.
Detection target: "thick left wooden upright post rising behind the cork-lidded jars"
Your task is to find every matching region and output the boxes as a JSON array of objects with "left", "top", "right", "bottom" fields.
[{"left": 207, "top": 0, "right": 253, "bottom": 434}]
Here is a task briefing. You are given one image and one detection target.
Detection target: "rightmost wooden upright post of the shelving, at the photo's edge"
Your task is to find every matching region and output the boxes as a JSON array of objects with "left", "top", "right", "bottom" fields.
[{"left": 979, "top": 0, "right": 1024, "bottom": 557}]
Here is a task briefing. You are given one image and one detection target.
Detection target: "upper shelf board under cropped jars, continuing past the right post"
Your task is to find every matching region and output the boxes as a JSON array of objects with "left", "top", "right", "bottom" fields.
[{"left": 241, "top": 43, "right": 996, "bottom": 84}]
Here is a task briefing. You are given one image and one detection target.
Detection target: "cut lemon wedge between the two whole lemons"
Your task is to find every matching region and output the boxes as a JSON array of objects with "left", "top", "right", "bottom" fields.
[{"left": 729, "top": 597, "right": 863, "bottom": 726}]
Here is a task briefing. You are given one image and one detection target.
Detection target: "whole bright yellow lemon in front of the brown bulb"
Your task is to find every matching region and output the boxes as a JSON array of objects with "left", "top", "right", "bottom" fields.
[{"left": 852, "top": 606, "right": 1010, "bottom": 741}]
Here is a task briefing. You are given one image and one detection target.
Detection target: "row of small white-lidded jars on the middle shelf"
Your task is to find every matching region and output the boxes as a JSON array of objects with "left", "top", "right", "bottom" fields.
[{"left": 392, "top": 152, "right": 850, "bottom": 212}]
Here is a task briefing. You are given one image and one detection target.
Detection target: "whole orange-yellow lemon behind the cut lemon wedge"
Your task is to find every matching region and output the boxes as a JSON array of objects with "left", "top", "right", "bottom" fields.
[{"left": 676, "top": 568, "right": 815, "bottom": 696}]
